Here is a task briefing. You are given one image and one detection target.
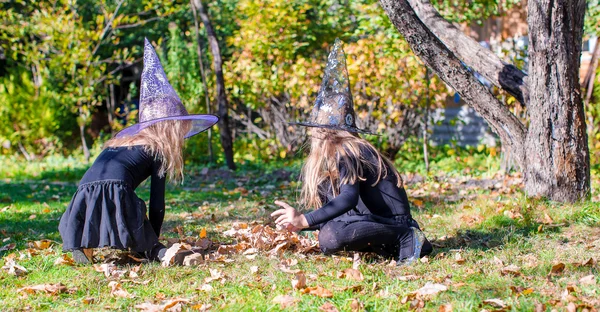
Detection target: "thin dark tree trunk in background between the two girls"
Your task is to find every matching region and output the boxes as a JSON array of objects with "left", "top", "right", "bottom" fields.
[{"left": 194, "top": 0, "right": 235, "bottom": 170}]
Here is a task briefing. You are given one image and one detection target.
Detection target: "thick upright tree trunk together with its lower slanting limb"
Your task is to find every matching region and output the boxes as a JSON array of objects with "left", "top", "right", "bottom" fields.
[{"left": 380, "top": 0, "right": 590, "bottom": 202}]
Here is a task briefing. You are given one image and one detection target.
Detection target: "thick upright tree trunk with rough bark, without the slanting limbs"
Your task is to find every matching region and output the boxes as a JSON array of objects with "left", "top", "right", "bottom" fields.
[{"left": 525, "top": 0, "right": 590, "bottom": 202}]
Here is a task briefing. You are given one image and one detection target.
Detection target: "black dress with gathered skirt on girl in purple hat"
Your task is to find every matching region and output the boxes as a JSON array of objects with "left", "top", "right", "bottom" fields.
[{"left": 58, "top": 145, "right": 165, "bottom": 252}]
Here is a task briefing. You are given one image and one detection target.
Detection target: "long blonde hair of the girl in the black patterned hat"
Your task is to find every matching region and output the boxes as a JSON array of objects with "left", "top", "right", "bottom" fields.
[{"left": 300, "top": 128, "right": 402, "bottom": 208}]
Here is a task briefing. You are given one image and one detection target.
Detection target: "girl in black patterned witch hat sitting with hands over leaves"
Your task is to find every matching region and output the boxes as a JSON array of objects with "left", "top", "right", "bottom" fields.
[{"left": 271, "top": 39, "right": 432, "bottom": 264}]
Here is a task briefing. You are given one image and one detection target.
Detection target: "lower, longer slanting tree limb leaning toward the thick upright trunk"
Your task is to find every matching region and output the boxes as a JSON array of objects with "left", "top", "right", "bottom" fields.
[{"left": 380, "top": 0, "right": 526, "bottom": 167}]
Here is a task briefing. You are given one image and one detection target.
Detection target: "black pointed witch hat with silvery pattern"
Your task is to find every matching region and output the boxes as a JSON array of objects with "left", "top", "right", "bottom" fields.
[{"left": 290, "top": 39, "right": 372, "bottom": 134}]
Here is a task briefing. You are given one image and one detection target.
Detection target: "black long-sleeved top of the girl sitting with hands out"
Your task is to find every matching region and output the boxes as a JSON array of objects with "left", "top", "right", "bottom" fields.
[{"left": 304, "top": 148, "right": 410, "bottom": 227}]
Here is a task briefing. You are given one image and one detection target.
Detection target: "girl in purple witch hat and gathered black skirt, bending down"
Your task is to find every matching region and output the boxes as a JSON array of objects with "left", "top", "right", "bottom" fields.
[{"left": 58, "top": 39, "right": 218, "bottom": 263}]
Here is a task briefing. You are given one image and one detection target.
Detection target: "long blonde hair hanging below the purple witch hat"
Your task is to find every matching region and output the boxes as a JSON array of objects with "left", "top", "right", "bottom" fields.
[{"left": 104, "top": 120, "right": 192, "bottom": 183}]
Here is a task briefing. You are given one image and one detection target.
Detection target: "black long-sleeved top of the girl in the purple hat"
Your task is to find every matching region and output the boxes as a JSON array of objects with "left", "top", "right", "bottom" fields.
[{"left": 80, "top": 145, "right": 166, "bottom": 236}]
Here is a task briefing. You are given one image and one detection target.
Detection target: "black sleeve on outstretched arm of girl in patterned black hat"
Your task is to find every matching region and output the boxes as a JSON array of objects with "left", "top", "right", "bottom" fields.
[{"left": 304, "top": 161, "right": 360, "bottom": 227}]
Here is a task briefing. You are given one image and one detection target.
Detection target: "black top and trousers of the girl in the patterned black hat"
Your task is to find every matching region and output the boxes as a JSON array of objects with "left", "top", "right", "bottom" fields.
[{"left": 304, "top": 148, "right": 432, "bottom": 258}]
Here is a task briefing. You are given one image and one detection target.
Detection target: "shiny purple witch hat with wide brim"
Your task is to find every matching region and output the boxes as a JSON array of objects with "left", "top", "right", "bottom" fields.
[{"left": 116, "top": 38, "right": 219, "bottom": 138}]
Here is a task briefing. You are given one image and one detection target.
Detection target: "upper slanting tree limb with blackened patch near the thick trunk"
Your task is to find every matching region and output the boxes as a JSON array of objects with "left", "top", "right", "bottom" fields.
[{"left": 408, "top": 0, "right": 529, "bottom": 106}]
